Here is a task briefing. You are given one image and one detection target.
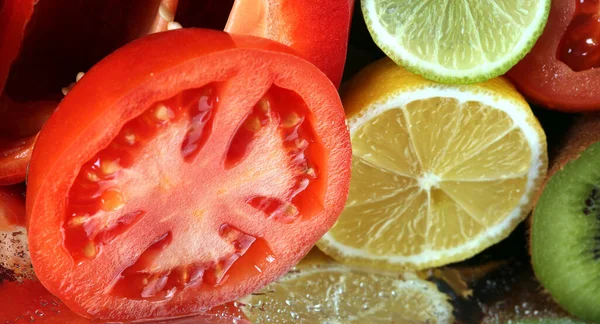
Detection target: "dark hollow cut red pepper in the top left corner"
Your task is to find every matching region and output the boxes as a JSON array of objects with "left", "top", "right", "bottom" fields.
[{"left": 0, "top": 0, "right": 177, "bottom": 185}]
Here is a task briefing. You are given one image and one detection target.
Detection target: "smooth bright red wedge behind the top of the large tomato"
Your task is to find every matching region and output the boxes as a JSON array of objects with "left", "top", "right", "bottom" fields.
[{"left": 225, "top": 0, "right": 354, "bottom": 86}]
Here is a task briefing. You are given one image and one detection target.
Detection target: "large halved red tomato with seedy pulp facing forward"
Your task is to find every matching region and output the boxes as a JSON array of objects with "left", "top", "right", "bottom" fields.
[{"left": 27, "top": 29, "right": 351, "bottom": 321}]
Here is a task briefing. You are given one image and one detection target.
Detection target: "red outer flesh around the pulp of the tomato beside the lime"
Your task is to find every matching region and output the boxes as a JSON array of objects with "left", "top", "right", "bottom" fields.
[{"left": 507, "top": 0, "right": 600, "bottom": 112}]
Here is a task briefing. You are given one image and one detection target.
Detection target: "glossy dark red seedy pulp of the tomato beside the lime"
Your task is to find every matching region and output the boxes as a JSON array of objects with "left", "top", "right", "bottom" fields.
[{"left": 558, "top": 0, "right": 600, "bottom": 71}]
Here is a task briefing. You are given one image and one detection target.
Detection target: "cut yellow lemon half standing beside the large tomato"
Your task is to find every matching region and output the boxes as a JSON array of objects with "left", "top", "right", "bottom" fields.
[{"left": 317, "top": 59, "right": 548, "bottom": 270}]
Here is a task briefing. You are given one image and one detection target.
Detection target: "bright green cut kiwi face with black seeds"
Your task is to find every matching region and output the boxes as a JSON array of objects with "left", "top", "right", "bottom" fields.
[{"left": 530, "top": 142, "right": 600, "bottom": 322}]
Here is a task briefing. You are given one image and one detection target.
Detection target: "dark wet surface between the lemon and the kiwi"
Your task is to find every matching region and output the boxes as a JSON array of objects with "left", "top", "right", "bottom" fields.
[{"left": 442, "top": 223, "right": 569, "bottom": 323}]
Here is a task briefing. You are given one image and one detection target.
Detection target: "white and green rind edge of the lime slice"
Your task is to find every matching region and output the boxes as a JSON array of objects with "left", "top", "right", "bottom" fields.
[{"left": 361, "top": 0, "right": 551, "bottom": 84}]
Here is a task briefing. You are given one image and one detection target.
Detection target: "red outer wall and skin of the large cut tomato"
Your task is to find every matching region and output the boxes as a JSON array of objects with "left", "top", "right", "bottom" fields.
[{"left": 26, "top": 29, "right": 351, "bottom": 321}]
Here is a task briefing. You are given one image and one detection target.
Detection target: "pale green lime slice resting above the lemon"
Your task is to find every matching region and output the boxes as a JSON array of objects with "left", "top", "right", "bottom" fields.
[{"left": 362, "top": 0, "right": 550, "bottom": 83}]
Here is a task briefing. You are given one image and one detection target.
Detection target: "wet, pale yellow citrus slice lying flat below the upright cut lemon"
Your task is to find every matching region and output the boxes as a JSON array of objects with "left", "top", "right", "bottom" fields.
[{"left": 238, "top": 249, "right": 453, "bottom": 324}]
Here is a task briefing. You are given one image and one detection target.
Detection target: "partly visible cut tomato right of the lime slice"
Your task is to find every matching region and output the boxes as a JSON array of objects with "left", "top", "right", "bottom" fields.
[{"left": 507, "top": 0, "right": 600, "bottom": 112}]
